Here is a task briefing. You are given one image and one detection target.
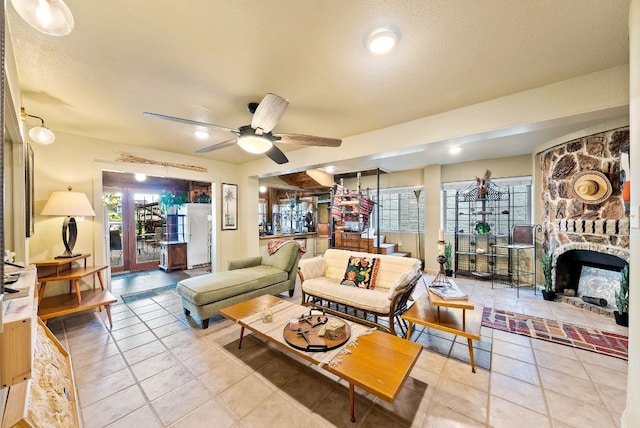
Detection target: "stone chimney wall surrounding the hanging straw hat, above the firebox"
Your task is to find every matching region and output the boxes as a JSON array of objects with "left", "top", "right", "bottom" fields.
[{"left": 540, "top": 127, "right": 629, "bottom": 288}]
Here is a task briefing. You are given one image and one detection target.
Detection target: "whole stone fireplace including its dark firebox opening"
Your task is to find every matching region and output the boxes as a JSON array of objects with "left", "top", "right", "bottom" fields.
[{"left": 541, "top": 127, "right": 630, "bottom": 310}]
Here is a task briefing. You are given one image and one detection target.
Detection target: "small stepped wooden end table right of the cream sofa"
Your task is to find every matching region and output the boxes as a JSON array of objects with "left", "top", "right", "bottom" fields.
[{"left": 402, "top": 279, "right": 484, "bottom": 373}]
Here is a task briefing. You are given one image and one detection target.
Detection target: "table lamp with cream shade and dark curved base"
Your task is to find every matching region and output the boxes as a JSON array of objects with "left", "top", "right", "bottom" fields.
[{"left": 40, "top": 187, "right": 96, "bottom": 259}]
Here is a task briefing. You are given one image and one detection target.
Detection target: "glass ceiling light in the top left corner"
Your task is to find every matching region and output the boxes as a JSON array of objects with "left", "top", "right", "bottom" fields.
[{"left": 11, "top": 0, "right": 74, "bottom": 36}]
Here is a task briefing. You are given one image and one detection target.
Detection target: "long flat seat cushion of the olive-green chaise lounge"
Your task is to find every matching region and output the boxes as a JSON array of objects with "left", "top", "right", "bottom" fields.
[{"left": 176, "top": 266, "right": 284, "bottom": 305}]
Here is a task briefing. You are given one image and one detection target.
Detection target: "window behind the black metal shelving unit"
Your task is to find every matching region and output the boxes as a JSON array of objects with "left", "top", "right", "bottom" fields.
[{"left": 442, "top": 177, "right": 532, "bottom": 233}]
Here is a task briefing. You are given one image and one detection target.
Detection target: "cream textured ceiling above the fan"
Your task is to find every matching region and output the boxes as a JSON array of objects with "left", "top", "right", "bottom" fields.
[{"left": 6, "top": 0, "right": 629, "bottom": 171}]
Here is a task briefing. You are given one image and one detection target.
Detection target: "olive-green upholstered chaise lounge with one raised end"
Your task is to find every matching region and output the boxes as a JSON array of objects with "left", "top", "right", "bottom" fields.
[{"left": 176, "top": 241, "right": 300, "bottom": 329}]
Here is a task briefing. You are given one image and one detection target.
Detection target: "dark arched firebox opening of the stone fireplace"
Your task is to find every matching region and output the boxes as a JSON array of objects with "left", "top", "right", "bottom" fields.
[{"left": 555, "top": 250, "right": 627, "bottom": 308}]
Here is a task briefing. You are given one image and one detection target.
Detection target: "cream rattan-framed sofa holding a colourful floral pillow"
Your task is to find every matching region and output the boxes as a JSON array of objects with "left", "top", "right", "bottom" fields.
[{"left": 299, "top": 249, "right": 422, "bottom": 334}]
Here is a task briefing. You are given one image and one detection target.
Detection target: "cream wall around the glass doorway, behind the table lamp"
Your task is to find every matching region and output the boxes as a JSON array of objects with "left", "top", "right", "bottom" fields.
[{"left": 29, "top": 132, "right": 244, "bottom": 295}]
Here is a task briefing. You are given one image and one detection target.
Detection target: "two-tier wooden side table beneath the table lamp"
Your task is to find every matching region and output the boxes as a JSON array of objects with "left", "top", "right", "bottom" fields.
[{"left": 34, "top": 254, "right": 117, "bottom": 326}]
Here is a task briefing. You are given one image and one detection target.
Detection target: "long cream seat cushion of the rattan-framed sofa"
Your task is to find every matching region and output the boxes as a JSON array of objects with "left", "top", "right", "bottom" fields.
[{"left": 302, "top": 277, "right": 391, "bottom": 313}]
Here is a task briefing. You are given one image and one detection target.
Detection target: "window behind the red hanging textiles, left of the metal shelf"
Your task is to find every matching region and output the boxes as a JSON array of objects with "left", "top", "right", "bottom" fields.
[{"left": 369, "top": 186, "right": 424, "bottom": 233}]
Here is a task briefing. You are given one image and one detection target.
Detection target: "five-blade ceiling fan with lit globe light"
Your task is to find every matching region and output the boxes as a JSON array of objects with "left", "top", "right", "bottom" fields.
[{"left": 142, "top": 93, "right": 342, "bottom": 164}]
